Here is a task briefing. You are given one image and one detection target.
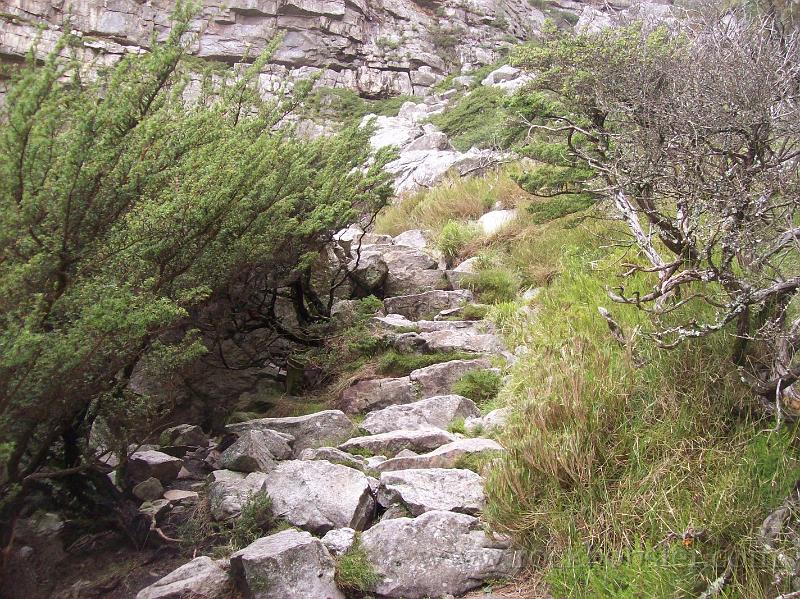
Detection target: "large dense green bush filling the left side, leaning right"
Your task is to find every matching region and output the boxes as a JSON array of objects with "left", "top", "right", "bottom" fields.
[{"left": 0, "top": 6, "right": 389, "bottom": 530}]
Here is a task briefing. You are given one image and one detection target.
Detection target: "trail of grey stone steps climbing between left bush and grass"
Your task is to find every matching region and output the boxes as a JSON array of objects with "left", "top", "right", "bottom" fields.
[{"left": 134, "top": 223, "right": 522, "bottom": 599}]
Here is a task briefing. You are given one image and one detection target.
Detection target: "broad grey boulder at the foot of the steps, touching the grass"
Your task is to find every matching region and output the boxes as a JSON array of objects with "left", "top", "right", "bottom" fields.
[{"left": 361, "top": 510, "right": 522, "bottom": 599}]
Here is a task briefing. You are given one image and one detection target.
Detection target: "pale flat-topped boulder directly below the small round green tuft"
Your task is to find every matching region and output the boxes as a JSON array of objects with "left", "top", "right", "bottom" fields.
[{"left": 361, "top": 395, "right": 480, "bottom": 435}]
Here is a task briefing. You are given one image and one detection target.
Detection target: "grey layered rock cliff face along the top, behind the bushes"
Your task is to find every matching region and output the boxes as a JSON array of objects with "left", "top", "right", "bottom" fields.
[{"left": 0, "top": 0, "right": 544, "bottom": 97}]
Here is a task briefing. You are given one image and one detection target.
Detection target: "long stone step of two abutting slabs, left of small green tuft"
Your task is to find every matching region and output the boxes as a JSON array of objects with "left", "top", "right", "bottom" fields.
[{"left": 339, "top": 358, "right": 491, "bottom": 414}]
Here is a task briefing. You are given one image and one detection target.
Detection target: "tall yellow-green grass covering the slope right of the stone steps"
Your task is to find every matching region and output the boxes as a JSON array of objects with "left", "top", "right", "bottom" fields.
[{"left": 485, "top": 221, "right": 800, "bottom": 599}]
